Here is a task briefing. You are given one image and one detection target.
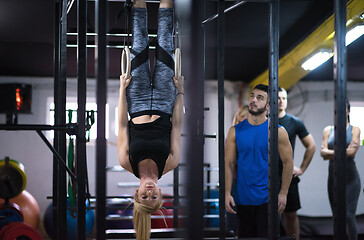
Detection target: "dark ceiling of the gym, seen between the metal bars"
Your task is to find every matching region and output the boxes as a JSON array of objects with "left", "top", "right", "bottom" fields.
[{"left": 0, "top": 0, "right": 364, "bottom": 85}]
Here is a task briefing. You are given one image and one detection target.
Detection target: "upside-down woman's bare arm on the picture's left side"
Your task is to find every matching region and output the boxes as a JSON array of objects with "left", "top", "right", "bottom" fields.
[{"left": 118, "top": 75, "right": 133, "bottom": 173}]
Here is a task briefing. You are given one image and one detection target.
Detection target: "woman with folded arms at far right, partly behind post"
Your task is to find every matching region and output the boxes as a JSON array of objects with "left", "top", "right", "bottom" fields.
[{"left": 321, "top": 101, "right": 361, "bottom": 240}]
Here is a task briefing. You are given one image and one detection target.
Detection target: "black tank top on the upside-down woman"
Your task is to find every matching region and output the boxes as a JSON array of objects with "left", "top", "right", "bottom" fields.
[{"left": 129, "top": 115, "right": 172, "bottom": 178}]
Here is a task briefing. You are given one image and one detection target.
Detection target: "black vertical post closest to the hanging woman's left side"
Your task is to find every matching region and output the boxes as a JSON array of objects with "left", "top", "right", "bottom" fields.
[{"left": 95, "top": 0, "right": 108, "bottom": 240}]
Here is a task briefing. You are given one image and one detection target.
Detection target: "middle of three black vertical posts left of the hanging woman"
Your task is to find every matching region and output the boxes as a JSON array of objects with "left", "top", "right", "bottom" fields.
[{"left": 76, "top": 0, "right": 87, "bottom": 240}]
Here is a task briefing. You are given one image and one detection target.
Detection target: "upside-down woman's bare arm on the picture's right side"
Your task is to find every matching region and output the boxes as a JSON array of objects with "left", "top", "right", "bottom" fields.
[{"left": 163, "top": 76, "right": 184, "bottom": 174}]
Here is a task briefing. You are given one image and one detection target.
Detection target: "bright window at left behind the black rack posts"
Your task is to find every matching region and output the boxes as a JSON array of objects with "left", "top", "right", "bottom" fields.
[{"left": 49, "top": 102, "right": 109, "bottom": 140}]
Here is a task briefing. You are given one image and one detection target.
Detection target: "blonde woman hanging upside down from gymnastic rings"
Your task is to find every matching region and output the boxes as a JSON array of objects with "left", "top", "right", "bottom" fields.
[{"left": 118, "top": 0, "right": 184, "bottom": 240}]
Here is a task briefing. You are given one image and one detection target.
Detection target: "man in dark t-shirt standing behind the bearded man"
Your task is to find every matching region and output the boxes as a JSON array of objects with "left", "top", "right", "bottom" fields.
[{"left": 278, "top": 88, "right": 316, "bottom": 240}]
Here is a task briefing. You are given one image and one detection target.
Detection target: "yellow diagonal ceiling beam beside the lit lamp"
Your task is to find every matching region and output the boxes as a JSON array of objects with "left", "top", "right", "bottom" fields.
[{"left": 249, "top": 0, "right": 364, "bottom": 89}]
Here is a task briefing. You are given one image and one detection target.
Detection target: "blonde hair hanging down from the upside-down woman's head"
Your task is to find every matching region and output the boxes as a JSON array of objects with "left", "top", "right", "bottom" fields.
[{"left": 133, "top": 193, "right": 162, "bottom": 240}]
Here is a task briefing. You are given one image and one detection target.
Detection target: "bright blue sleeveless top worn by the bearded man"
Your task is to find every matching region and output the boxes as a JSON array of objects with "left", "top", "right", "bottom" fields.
[{"left": 235, "top": 119, "right": 280, "bottom": 205}]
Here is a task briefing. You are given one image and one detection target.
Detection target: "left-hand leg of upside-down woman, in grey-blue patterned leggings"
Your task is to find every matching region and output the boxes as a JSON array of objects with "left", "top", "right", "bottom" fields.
[{"left": 127, "top": 0, "right": 152, "bottom": 115}]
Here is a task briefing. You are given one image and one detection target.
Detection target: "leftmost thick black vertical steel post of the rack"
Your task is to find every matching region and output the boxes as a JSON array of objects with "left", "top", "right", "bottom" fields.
[{"left": 52, "top": 0, "right": 67, "bottom": 239}]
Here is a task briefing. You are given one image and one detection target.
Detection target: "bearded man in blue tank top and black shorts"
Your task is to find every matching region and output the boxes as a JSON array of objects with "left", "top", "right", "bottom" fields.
[{"left": 225, "top": 84, "right": 293, "bottom": 238}]
